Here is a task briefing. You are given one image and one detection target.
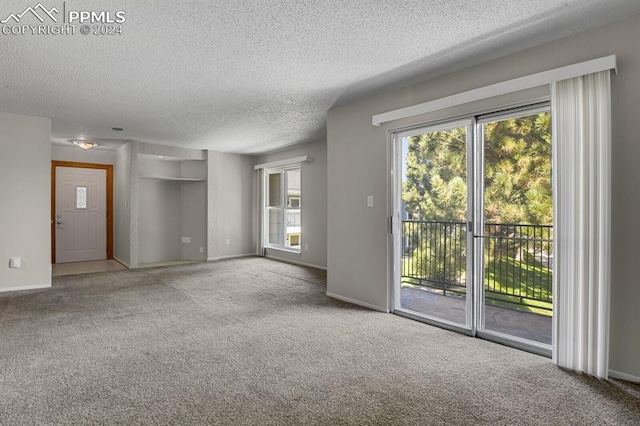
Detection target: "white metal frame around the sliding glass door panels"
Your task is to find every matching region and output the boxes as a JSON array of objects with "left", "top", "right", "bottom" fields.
[{"left": 387, "top": 100, "right": 556, "bottom": 358}]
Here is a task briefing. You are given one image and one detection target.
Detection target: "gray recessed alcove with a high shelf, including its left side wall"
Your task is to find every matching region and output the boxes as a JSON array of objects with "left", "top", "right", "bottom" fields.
[{"left": 115, "top": 146, "right": 207, "bottom": 268}]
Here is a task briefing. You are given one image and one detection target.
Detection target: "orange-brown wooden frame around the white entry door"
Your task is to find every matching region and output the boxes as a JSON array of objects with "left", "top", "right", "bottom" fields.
[{"left": 51, "top": 160, "right": 113, "bottom": 264}]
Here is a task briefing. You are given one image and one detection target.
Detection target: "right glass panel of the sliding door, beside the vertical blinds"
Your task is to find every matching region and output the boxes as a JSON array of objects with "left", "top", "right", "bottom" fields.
[{"left": 475, "top": 110, "right": 553, "bottom": 345}]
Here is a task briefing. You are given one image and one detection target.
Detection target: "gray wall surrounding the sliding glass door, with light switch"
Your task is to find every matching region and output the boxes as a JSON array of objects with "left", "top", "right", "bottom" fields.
[{"left": 327, "top": 16, "right": 640, "bottom": 377}]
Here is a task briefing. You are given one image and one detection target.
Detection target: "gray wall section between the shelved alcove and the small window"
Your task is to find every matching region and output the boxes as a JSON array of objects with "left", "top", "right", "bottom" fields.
[{"left": 207, "top": 151, "right": 256, "bottom": 260}]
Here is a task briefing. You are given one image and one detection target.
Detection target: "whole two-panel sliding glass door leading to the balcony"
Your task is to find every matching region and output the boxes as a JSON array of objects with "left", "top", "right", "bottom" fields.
[{"left": 392, "top": 106, "right": 553, "bottom": 354}]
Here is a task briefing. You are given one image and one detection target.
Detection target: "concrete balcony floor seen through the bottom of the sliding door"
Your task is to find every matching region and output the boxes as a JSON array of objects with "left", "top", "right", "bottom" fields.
[{"left": 401, "top": 286, "right": 552, "bottom": 345}]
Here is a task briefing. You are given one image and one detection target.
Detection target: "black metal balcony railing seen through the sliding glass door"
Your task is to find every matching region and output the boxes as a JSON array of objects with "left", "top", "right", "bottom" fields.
[{"left": 402, "top": 220, "right": 553, "bottom": 312}]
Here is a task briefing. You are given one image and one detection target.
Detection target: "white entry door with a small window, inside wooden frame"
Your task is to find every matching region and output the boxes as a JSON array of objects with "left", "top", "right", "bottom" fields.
[{"left": 55, "top": 166, "right": 107, "bottom": 263}]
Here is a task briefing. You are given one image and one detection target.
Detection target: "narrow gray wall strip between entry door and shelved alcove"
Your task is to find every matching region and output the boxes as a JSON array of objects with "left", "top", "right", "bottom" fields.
[{"left": 113, "top": 143, "right": 132, "bottom": 266}]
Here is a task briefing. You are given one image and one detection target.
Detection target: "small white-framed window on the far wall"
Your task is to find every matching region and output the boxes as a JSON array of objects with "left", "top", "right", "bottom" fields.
[{"left": 264, "top": 166, "right": 302, "bottom": 252}]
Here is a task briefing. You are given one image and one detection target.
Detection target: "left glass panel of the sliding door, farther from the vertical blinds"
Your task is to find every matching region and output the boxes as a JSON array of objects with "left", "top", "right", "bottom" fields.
[{"left": 395, "top": 122, "right": 472, "bottom": 328}]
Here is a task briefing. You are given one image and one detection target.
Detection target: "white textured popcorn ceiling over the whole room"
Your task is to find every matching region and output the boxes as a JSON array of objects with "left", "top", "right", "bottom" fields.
[{"left": 0, "top": 0, "right": 640, "bottom": 153}]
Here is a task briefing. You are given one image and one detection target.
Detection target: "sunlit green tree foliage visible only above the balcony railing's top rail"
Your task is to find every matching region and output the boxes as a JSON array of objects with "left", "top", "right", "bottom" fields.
[{"left": 402, "top": 113, "right": 553, "bottom": 224}]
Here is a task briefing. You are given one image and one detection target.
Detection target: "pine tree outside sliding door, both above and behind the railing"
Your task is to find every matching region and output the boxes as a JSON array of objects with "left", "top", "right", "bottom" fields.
[{"left": 402, "top": 113, "right": 553, "bottom": 288}]
